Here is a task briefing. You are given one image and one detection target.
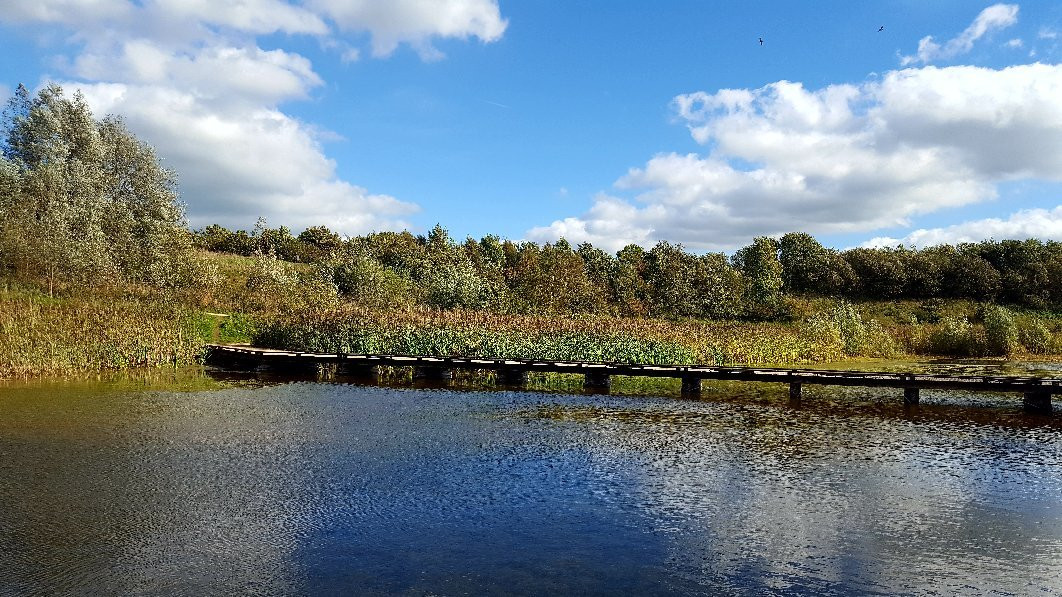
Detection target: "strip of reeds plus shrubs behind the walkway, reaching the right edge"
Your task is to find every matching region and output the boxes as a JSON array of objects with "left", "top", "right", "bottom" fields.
[{"left": 252, "top": 301, "right": 1060, "bottom": 364}]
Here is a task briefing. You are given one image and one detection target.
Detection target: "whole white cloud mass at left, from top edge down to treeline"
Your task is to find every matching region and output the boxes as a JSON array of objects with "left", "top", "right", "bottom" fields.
[{"left": 0, "top": 0, "right": 506, "bottom": 234}]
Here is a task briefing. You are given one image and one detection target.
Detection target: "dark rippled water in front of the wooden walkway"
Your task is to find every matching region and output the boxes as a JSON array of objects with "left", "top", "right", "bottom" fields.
[{"left": 0, "top": 369, "right": 1062, "bottom": 595}]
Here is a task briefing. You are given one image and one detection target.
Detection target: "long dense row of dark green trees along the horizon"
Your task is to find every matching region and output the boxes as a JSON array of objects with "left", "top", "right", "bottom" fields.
[{"left": 198, "top": 222, "right": 1062, "bottom": 320}]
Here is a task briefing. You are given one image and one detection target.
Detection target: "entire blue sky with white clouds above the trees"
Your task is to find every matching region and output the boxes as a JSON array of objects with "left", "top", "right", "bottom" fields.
[{"left": 0, "top": 0, "right": 1062, "bottom": 251}]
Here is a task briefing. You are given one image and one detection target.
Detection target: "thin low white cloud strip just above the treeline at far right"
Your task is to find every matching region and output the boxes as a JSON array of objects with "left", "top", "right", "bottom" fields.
[{"left": 863, "top": 205, "right": 1062, "bottom": 249}]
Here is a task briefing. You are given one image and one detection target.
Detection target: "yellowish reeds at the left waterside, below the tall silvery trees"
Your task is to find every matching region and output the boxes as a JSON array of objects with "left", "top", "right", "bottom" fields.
[{"left": 0, "top": 282, "right": 204, "bottom": 377}]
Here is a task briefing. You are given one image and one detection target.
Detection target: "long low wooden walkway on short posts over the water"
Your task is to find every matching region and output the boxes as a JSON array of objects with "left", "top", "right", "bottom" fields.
[{"left": 207, "top": 345, "right": 1062, "bottom": 413}]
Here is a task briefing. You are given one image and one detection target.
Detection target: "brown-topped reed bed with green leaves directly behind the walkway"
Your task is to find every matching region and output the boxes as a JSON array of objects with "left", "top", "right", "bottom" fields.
[{"left": 253, "top": 306, "right": 843, "bottom": 364}]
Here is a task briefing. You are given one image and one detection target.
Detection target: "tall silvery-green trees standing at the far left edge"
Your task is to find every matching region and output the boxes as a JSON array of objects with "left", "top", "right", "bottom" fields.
[{"left": 0, "top": 85, "right": 194, "bottom": 290}]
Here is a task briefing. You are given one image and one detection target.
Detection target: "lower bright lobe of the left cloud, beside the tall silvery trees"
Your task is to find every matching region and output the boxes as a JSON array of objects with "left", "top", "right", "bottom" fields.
[{"left": 79, "top": 84, "right": 417, "bottom": 234}]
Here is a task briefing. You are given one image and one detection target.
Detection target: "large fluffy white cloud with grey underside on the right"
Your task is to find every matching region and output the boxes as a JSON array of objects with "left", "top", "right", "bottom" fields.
[{"left": 528, "top": 64, "right": 1062, "bottom": 250}]
